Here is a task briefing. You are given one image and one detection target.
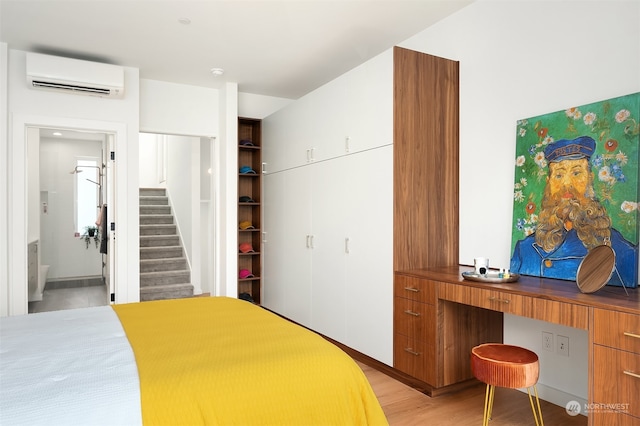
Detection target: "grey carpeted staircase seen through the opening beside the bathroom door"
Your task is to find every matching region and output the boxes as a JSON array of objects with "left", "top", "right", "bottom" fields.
[{"left": 140, "top": 188, "right": 193, "bottom": 301}]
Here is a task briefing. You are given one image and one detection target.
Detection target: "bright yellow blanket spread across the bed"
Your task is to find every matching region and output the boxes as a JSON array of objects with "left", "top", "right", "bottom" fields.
[{"left": 113, "top": 297, "right": 387, "bottom": 426}]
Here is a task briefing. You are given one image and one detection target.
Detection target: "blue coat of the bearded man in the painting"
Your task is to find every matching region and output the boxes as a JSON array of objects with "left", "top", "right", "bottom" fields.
[{"left": 510, "top": 229, "right": 638, "bottom": 288}]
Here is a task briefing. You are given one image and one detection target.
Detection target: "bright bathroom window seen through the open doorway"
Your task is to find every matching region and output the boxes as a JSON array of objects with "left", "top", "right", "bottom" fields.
[{"left": 74, "top": 159, "right": 101, "bottom": 235}]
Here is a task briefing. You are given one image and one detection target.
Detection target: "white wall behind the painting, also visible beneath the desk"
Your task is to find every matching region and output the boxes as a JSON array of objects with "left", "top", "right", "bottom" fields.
[{"left": 401, "top": 0, "right": 640, "bottom": 405}]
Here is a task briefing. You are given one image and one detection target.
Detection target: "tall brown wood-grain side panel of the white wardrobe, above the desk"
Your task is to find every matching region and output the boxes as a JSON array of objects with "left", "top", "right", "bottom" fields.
[{"left": 393, "top": 48, "right": 459, "bottom": 271}]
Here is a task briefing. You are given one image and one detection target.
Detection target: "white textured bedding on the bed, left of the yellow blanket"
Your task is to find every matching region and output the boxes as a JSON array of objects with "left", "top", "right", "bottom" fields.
[{"left": 0, "top": 306, "right": 142, "bottom": 426}]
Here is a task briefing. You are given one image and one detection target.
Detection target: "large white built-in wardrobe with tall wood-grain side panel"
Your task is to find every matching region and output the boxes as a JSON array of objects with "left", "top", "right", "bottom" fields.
[{"left": 263, "top": 48, "right": 458, "bottom": 365}]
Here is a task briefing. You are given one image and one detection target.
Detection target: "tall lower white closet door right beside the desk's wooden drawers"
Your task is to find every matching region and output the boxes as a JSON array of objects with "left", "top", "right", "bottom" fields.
[{"left": 343, "top": 145, "right": 393, "bottom": 365}]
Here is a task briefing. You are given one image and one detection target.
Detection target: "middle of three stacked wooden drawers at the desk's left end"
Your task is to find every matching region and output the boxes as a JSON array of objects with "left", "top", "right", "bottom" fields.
[{"left": 393, "top": 297, "right": 436, "bottom": 342}]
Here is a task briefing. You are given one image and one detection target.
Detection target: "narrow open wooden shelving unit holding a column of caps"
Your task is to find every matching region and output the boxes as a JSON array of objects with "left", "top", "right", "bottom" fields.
[{"left": 238, "top": 118, "right": 262, "bottom": 304}]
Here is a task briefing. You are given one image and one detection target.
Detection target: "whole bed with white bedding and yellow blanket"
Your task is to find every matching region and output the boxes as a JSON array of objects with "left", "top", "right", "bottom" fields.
[{"left": 0, "top": 297, "right": 387, "bottom": 425}]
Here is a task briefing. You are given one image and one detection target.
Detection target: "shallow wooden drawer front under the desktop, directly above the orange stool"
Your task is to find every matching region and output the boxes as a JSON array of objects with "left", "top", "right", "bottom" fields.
[{"left": 438, "top": 283, "right": 531, "bottom": 316}]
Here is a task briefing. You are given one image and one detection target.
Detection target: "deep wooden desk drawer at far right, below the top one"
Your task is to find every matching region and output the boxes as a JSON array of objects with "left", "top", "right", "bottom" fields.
[{"left": 593, "top": 345, "right": 640, "bottom": 417}]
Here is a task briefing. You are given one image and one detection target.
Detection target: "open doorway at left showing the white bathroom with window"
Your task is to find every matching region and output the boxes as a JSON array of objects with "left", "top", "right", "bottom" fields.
[{"left": 27, "top": 128, "right": 113, "bottom": 313}]
